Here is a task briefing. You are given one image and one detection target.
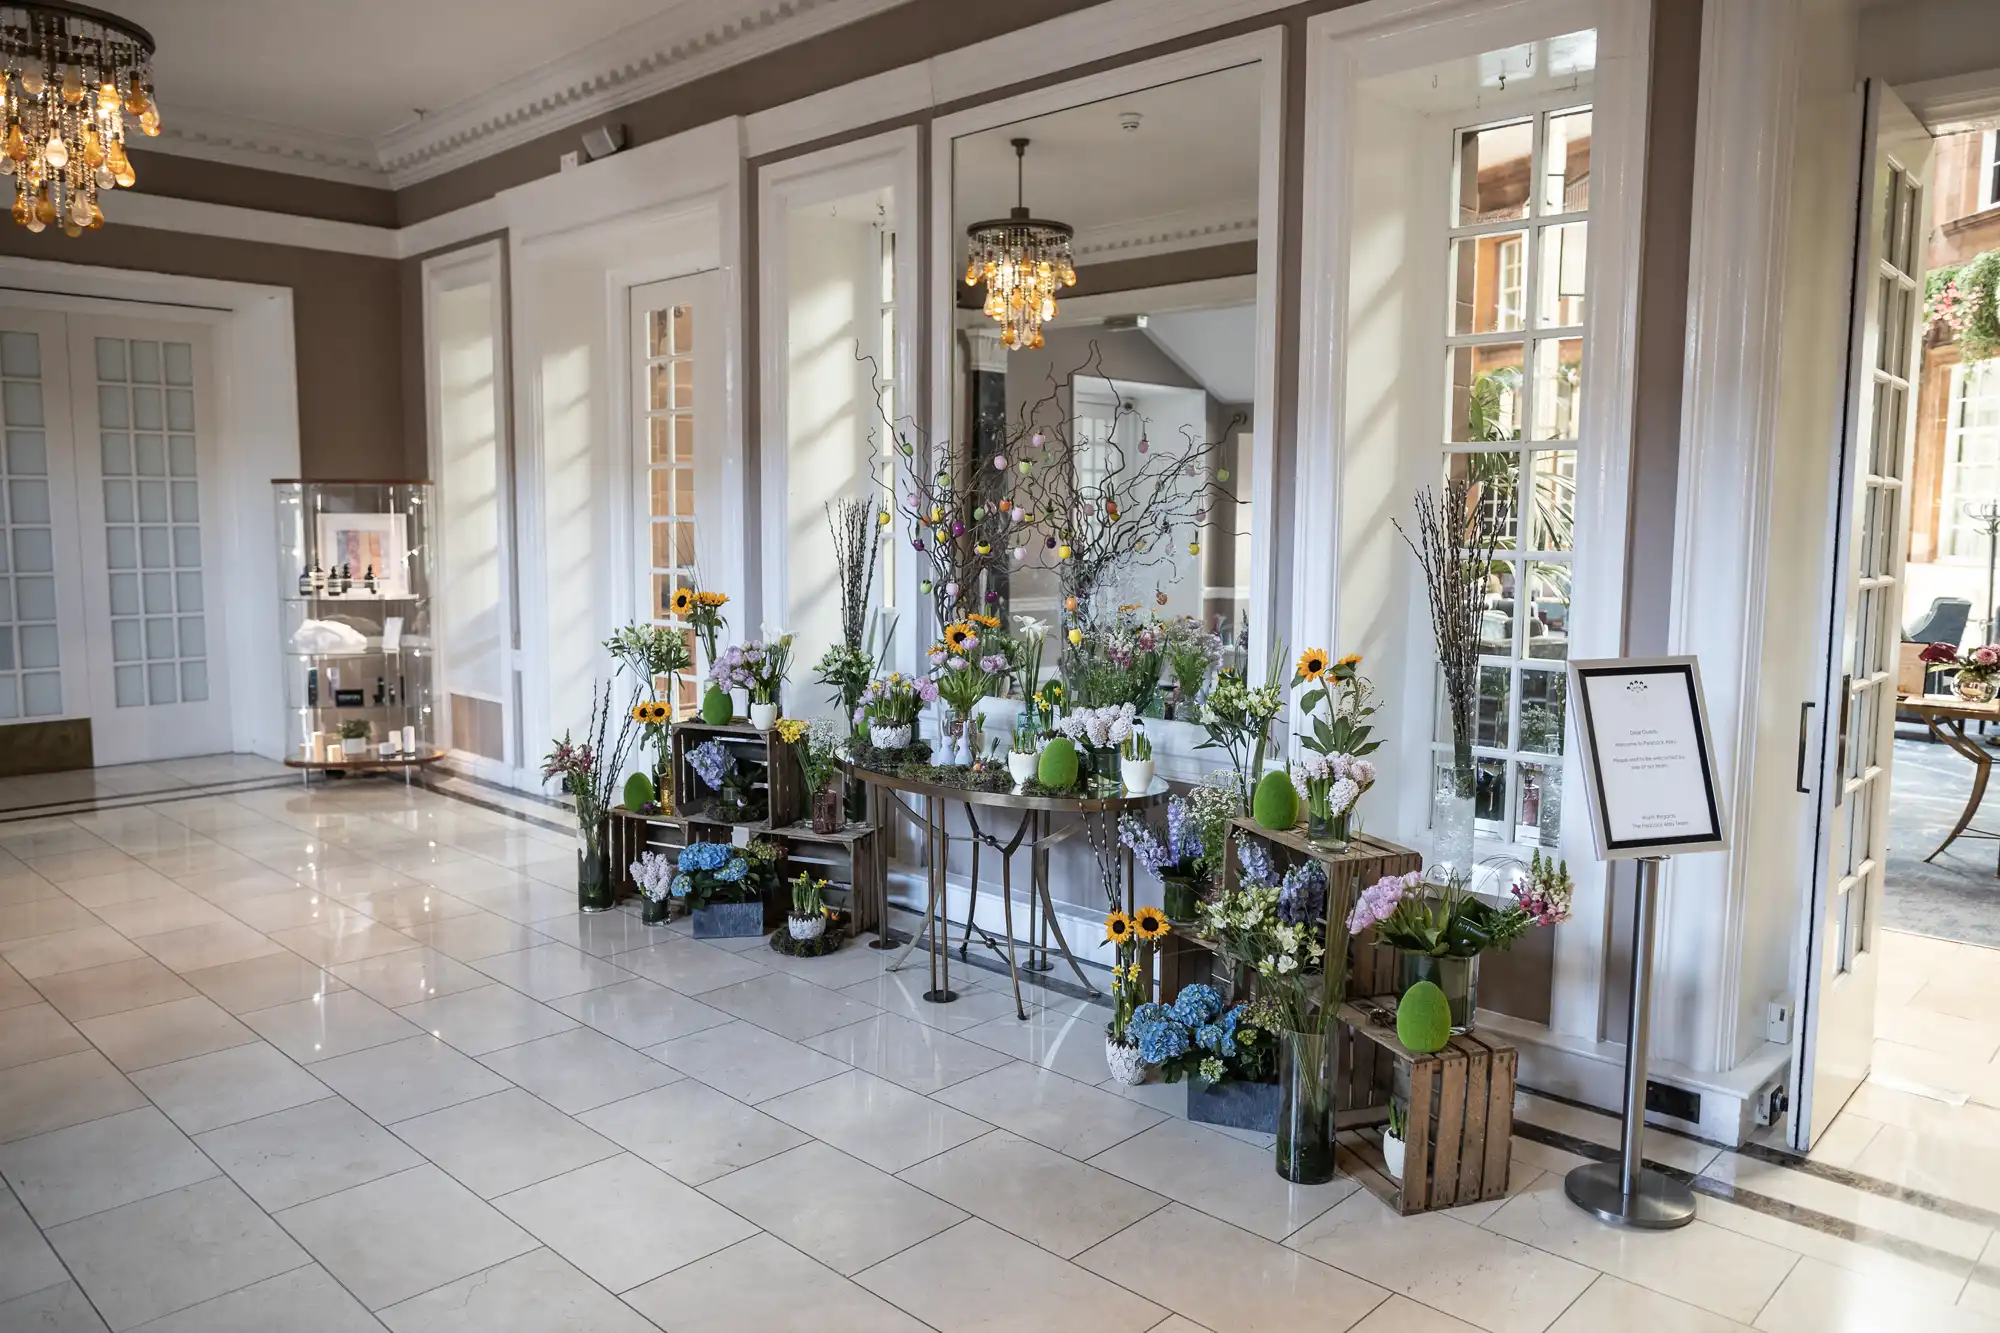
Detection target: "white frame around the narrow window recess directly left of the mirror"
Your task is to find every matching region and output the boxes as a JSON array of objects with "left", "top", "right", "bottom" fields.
[{"left": 756, "top": 126, "right": 924, "bottom": 673}]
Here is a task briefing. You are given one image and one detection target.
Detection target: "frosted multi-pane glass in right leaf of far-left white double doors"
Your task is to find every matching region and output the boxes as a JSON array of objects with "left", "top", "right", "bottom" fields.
[{"left": 96, "top": 338, "right": 208, "bottom": 709}]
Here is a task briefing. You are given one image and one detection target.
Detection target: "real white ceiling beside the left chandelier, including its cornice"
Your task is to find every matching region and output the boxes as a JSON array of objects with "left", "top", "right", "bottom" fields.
[{"left": 119, "top": 0, "right": 900, "bottom": 186}]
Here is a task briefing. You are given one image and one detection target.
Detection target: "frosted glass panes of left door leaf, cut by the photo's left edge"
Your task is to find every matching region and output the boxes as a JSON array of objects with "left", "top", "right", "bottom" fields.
[{"left": 0, "top": 332, "right": 62, "bottom": 719}]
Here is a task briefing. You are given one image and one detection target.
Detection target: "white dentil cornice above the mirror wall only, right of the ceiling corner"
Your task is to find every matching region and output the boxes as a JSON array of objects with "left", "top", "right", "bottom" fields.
[{"left": 376, "top": 0, "right": 902, "bottom": 188}]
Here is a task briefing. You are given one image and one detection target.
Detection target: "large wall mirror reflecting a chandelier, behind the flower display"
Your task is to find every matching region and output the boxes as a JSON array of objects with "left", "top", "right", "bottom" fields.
[{"left": 932, "top": 38, "right": 1284, "bottom": 732}]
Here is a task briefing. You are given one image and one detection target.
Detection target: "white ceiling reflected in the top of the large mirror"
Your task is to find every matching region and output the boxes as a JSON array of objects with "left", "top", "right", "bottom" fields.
[{"left": 952, "top": 64, "right": 1260, "bottom": 262}]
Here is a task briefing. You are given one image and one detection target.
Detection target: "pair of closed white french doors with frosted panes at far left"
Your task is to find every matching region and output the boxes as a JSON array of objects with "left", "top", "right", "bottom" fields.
[{"left": 0, "top": 308, "right": 230, "bottom": 765}]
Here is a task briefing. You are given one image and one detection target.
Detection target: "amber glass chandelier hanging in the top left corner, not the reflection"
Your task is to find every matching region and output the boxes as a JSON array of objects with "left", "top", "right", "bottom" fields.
[{"left": 0, "top": 4, "right": 160, "bottom": 236}]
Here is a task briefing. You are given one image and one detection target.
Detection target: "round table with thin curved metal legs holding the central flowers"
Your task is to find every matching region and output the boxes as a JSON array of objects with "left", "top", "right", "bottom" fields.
[{"left": 848, "top": 765, "right": 1170, "bottom": 1019}]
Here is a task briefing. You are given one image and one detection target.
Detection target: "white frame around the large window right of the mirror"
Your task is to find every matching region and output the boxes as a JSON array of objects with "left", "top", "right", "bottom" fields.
[{"left": 1290, "top": 0, "right": 1652, "bottom": 1041}]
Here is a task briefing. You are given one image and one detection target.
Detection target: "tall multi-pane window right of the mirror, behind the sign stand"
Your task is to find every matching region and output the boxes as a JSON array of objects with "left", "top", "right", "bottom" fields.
[{"left": 1434, "top": 106, "right": 1590, "bottom": 847}]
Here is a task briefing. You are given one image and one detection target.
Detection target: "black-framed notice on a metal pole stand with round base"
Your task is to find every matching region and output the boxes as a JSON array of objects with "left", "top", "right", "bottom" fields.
[{"left": 1562, "top": 656, "right": 1728, "bottom": 1231}]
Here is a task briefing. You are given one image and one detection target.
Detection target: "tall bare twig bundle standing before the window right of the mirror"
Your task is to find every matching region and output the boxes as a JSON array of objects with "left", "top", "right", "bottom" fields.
[{"left": 1396, "top": 476, "right": 1504, "bottom": 773}]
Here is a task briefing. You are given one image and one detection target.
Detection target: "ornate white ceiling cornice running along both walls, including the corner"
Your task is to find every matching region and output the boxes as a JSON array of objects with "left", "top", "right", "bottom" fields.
[{"left": 148, "top": 0, "right": 904, "bottom": 188}]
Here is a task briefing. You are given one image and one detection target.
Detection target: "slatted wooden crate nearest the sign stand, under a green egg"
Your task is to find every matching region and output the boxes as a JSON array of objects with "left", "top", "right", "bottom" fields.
[{"left": 1336, "top": 995, "right": 1520, "bottom": 1213}]
